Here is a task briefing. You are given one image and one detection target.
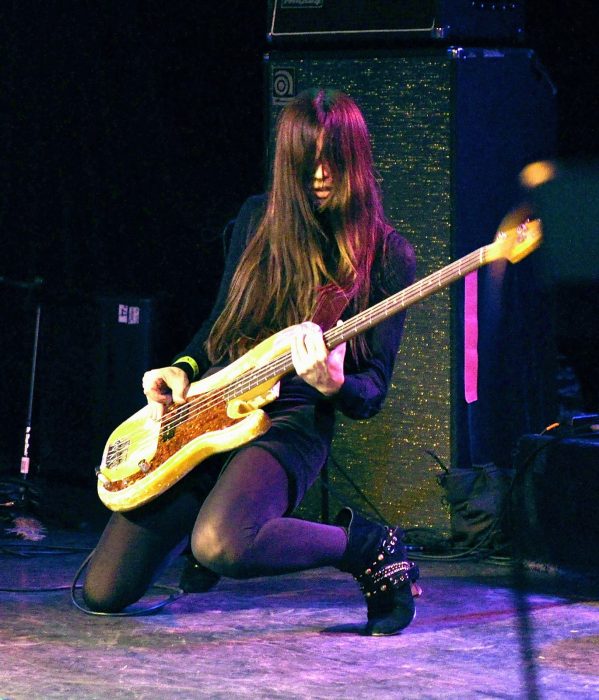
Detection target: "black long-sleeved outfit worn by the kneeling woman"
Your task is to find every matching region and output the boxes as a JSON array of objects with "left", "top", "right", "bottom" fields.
[{"left": 173, "top": 195, "right": 416, "bottom": 511}]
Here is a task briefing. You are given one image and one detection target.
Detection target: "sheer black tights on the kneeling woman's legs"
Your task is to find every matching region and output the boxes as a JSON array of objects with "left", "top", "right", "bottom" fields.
[{"left": 83, "top": 447, "right": 347, "bottom": 612}]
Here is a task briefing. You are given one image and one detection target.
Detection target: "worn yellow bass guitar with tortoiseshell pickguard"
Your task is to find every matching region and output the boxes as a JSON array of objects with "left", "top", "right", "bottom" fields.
[{"left": 96, "top": 219, "right": 542, "bottom": 511}]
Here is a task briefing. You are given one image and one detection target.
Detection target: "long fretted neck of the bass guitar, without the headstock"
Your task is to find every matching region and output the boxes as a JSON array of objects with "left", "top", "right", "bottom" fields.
[{"left": 226, "top": 241, "right": 494, "bottom": 400}]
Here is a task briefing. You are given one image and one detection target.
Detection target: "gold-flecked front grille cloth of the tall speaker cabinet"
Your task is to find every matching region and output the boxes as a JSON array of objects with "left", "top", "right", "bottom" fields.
[{"left": 269, "top": 55, "right": 451, "bottom": 527}]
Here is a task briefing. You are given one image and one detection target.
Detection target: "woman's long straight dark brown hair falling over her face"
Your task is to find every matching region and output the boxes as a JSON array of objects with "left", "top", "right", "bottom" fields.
[{"left": 207, "top": 90, "right": 385, "bottom": 362}]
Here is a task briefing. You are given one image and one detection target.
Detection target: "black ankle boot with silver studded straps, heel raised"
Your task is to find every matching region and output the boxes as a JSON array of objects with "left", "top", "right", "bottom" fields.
[{"left": 335, "top": 508, "right": 422, "bottom": 636}]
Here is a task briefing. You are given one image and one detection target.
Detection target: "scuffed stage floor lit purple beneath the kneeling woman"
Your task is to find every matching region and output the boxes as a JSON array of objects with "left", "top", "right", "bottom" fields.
[{"left": 0, "top": 531, "right": 599, "bottom": 700}]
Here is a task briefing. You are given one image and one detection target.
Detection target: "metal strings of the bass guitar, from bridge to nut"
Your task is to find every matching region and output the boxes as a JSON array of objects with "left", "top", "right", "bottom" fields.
[{"left": 104, "top": 246, "right": 488, "bottom": 464}]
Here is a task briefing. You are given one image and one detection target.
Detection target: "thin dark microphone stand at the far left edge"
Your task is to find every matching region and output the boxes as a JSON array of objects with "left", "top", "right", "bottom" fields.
[{"left": 0, "top": 276, "right": 45, "bottom": 540}]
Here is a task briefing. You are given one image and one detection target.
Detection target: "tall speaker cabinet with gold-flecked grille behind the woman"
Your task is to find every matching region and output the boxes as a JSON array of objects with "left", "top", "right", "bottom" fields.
[{"left": 265, "top": 48, "right": 555, "bottom": 530}]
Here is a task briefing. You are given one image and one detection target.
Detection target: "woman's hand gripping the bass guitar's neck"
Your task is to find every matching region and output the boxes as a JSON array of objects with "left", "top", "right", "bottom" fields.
[{"left": 291, "top": 321, "right": 346, "bottom": 396}]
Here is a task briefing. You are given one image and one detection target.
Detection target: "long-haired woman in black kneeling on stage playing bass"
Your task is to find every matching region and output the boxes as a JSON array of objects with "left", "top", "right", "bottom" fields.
[{"left": 84, "top": 90, "right": 419, "bottom": 635}]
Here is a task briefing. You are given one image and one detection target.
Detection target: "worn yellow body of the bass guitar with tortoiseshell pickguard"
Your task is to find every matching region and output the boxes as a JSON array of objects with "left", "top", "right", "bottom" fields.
[{"left": 98, "top": 327, "right": 302, "bottom": 511}]
